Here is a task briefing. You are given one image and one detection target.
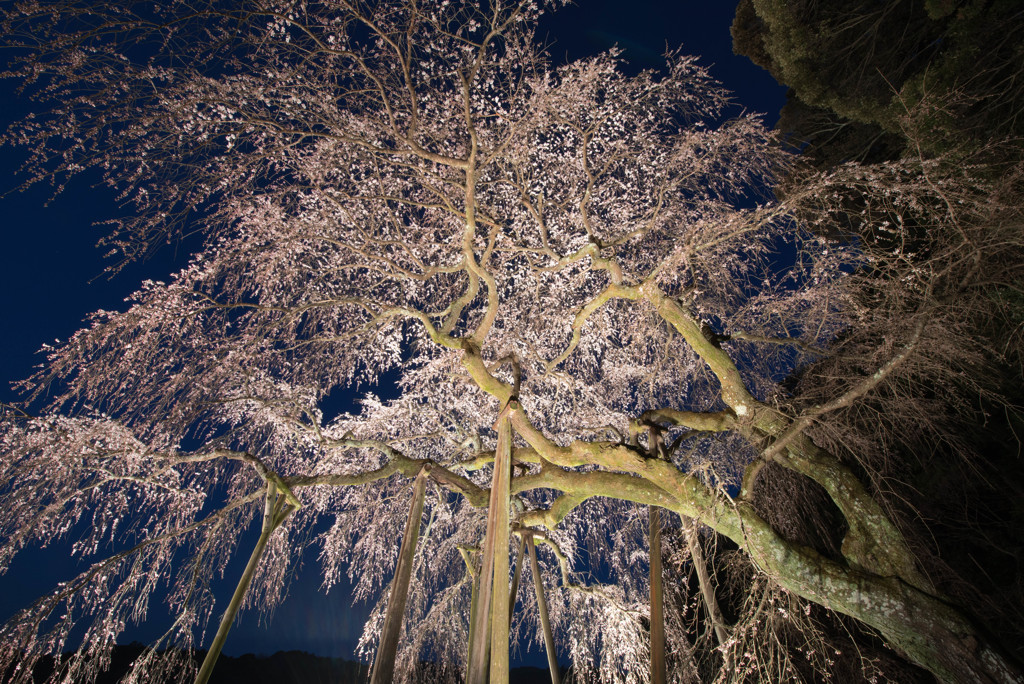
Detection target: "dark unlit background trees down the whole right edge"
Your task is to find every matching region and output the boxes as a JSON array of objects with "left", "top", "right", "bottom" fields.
[{"left": 733, "top": 0, "right": 1024, "bottom": 675}]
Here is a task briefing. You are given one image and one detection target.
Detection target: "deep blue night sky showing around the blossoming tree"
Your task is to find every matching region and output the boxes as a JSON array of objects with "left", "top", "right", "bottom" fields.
[{"left": 0, "top": 0, "right": 785, "bottom": 664}]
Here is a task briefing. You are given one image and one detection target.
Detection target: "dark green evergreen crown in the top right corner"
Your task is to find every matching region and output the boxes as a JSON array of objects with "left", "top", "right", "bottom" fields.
[{"left": 732, "top": 0, "right": 1024, "bottom": 166}]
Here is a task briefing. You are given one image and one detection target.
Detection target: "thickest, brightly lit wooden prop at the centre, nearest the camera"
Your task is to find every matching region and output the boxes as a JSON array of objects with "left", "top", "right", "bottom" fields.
[{"left": 466, "top": 398, "right": 518, "bottom": 684}]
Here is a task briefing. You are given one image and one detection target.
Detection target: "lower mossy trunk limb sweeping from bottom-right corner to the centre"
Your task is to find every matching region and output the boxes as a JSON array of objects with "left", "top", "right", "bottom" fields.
[{"left": 516, "top": 444, "right": 1024, "bottom": 684}]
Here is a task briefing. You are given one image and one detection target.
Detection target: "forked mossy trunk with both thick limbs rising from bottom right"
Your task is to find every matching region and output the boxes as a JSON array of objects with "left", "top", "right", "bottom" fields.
[{"left": 489, "top": 356, "right": 1024, "bottom": 684}]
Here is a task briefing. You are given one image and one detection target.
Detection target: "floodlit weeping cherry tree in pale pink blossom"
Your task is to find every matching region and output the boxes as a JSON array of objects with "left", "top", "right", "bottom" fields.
[{"left": 0, "top": 0, "right": 1022, "bottom": 682}]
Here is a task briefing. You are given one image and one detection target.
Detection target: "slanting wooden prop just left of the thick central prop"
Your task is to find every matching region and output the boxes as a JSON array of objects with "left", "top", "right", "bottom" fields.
[{"left": 370, "top": 466, "right": 428, "bottom": 684}]
